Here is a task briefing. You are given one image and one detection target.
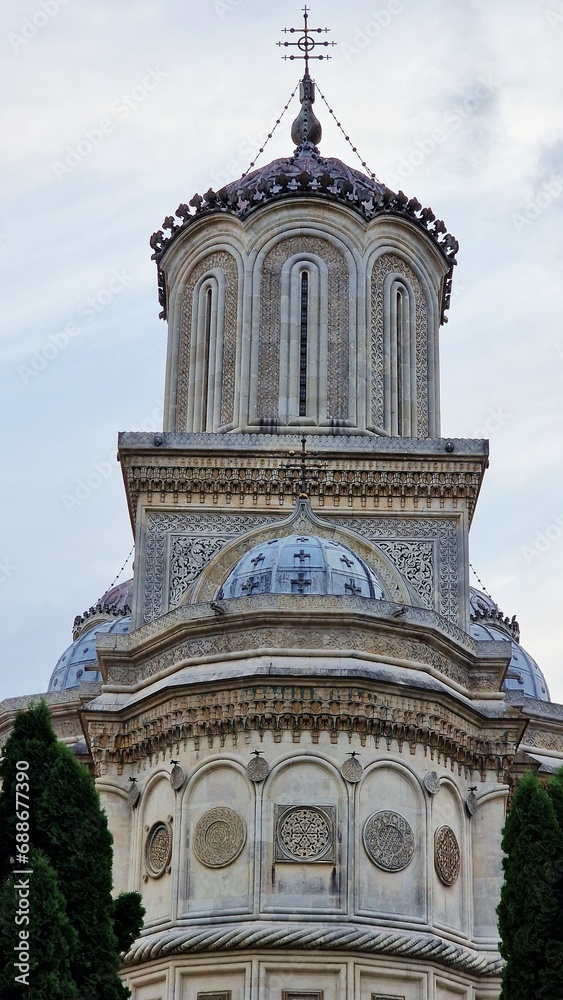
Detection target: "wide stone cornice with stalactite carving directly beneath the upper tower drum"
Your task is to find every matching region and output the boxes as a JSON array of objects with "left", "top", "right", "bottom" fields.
[{"left": 119, "top": 433, "right": 488, "bottom": 523}]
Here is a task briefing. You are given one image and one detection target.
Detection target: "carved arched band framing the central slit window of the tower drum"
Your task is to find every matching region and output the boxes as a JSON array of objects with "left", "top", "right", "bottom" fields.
[{"left": 258, "top": 236, "right": 350, "bottom": 420}]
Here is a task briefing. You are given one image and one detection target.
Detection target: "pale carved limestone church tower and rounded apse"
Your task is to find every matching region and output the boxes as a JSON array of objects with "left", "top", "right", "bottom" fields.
[{"left": 3, "top": 72, "right": 563, "bottom": 1000}]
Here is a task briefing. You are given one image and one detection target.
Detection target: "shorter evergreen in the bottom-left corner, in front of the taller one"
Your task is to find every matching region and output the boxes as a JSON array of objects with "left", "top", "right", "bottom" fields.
[{"left": 0, "top": 849, "right": 79, "bottom": 1000}]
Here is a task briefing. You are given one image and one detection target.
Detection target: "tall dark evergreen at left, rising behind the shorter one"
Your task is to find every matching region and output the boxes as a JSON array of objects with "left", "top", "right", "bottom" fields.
[{"left": 0, "top": 702, "right": 142, "bottom": 1000}]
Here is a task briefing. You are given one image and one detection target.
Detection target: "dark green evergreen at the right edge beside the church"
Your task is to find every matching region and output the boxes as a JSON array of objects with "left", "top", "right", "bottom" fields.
[{"left": 497, "top": 773, "right": 563, "bottom": 1000}]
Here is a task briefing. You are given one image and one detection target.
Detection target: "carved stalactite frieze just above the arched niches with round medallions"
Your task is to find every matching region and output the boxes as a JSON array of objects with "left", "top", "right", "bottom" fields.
[{"left": 87, "top": 683, "right": 520, "bottom": 776}]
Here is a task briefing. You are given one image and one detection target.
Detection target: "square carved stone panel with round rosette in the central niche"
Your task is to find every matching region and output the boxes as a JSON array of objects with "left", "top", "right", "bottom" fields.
[{"left": 275, "top": 806, "right": 336, "bottom": 862}]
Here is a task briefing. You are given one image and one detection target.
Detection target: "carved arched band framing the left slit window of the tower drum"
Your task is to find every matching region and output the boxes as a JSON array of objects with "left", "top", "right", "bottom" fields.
[{"left": 176, "top": 250, "right": 238, "bottom": 431}]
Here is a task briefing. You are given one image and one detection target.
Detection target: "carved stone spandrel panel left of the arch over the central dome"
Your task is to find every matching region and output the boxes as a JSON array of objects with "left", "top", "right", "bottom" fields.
[{"left": 143, "top": 512, "right": 275, "bottom": 622}]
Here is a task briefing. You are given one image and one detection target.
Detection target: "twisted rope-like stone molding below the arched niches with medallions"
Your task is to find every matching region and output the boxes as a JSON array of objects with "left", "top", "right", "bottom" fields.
[{"left": 124, "top": 920, "right": 504, "bottom": 976}]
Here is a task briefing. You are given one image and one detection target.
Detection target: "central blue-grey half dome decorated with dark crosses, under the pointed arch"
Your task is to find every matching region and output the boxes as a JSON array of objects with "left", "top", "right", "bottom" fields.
[{"left": 218, "top": 535, "right": 385, "bottom": 600}]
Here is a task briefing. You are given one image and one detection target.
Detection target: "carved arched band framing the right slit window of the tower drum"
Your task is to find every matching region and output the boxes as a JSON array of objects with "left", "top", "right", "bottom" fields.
[{"left": 371, "top": 254, "right": 429, "bottom": 437}]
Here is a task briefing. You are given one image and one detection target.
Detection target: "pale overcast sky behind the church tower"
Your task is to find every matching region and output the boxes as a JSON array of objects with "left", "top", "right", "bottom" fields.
[{"left": 0, "top": 0, "right": 563, "bottom": 702}]
